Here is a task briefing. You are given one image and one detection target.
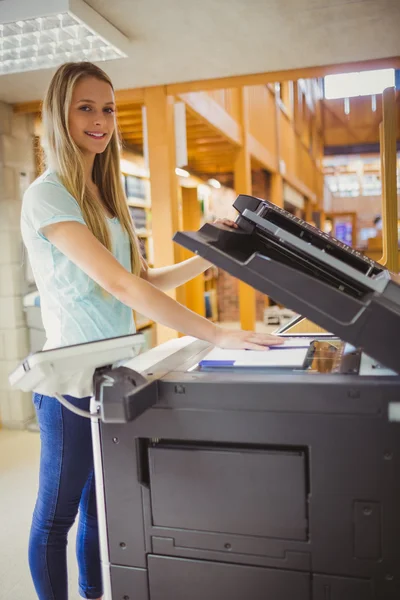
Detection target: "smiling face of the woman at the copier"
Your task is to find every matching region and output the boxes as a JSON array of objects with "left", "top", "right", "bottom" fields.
[{"left": 68, "top": 77, "right": 115, "bottom": 155}]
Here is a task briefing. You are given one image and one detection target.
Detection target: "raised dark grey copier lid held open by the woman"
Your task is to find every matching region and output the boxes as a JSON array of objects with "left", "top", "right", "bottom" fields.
[{"left": 174, "top": 195, "right": 400, "bottom": 373}]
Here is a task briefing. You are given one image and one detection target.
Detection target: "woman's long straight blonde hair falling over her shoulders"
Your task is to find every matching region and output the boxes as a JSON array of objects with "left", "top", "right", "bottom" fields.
[{"left": 42, "top": 62, "right": 144, "bottom": 275}]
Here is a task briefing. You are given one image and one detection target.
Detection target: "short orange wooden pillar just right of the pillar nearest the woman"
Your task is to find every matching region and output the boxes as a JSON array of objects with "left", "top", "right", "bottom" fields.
[{"left": 182, "top": 187, "right": 205, "bottom": 317}]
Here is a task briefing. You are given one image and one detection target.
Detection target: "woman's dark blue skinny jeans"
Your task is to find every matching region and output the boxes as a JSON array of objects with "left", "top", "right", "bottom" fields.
[{"left": 29, "top": 394, "right": 103, "bottom": 600}]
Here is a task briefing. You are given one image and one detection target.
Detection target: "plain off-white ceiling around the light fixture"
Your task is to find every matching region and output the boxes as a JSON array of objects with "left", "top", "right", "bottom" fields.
[{"left": 0, "top": 0, "right": 400, "bottom": 103}]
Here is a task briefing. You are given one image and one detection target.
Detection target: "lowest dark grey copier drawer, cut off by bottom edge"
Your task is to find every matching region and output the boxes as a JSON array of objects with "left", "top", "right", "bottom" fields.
[{"left": 148, "top": 556, "right": 311, "bottom": 600}]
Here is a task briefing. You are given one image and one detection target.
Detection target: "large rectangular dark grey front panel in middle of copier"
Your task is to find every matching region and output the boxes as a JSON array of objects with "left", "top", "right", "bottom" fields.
[{"left": 149, "top": 446, "right": 307, "bottom": 541}]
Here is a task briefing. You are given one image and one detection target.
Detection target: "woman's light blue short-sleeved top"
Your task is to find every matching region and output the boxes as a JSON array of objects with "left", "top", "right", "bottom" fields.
[{"left": 21, "top": 170, "right": 135, "bottom": 349}]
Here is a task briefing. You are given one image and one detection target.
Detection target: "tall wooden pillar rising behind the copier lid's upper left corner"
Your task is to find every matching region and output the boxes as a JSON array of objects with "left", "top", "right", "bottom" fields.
[{"left": 234, "top": 88, "right": 256, "bottom": 331}]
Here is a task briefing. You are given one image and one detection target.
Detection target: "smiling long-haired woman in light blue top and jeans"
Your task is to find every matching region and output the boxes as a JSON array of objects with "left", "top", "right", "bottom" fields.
[{"left": 21, "top": 63, "right": 279, "bottom": 600}]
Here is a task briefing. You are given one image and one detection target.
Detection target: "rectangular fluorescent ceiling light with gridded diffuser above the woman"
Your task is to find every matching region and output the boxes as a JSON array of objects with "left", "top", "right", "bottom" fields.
[{"left": 0, "top": 0, "right": 130, "bottom": 75}]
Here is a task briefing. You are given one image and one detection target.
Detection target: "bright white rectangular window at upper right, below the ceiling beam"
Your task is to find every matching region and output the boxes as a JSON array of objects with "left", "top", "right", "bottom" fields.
[{"left": 324, "top": 69, "right": 394, "bottom": 100}]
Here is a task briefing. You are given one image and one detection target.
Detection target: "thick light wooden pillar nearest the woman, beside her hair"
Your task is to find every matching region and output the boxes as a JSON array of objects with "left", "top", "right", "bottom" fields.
[{"left": 144, "top": 86, "right": 184, "bottom": 344}]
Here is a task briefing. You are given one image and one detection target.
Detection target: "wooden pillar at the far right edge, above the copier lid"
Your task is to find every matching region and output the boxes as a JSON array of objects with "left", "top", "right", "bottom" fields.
[{"left": 379, "top": 88, "right": 398, "bottom": 273}]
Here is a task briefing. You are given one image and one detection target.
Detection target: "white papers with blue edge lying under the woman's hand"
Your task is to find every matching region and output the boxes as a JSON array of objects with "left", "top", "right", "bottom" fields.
[{"left": 199, "top": 338, "right": 312, "bottom": 369}]
